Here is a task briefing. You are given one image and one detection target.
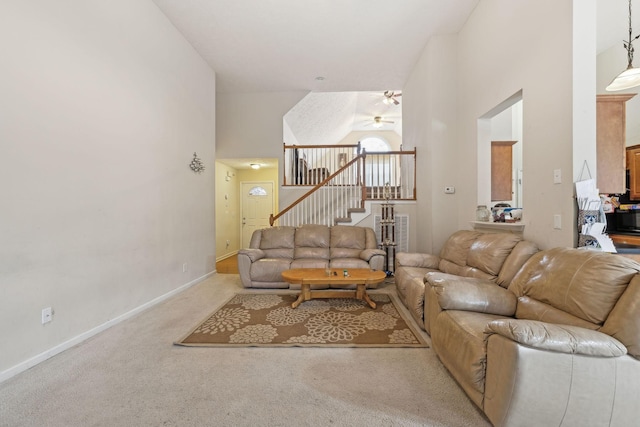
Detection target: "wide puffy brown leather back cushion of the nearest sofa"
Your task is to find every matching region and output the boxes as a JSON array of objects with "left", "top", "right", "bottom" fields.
[{"left": 509, "top": 248, "right": 639, "bottom": 325}]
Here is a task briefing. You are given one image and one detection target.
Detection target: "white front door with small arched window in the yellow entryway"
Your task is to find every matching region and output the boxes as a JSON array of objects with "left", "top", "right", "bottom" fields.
[{"left": 240, "top": 181, "right": 274, "bottom": 248}]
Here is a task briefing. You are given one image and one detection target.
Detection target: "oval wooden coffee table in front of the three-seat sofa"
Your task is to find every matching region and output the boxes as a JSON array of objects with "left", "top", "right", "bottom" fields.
[{"left": 282, "top": 268, "right": 387, "bottom": 308}]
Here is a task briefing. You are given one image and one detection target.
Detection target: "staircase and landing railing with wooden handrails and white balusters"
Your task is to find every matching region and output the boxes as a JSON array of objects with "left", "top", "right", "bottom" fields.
[{"left": 269, "top": 145, "right": 416, "bottom": 226}]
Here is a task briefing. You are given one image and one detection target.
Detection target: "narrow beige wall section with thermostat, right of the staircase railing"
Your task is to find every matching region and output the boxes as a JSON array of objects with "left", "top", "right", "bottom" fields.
[{"left": 402, "top": 35, "right": 460, "bottom": 253}]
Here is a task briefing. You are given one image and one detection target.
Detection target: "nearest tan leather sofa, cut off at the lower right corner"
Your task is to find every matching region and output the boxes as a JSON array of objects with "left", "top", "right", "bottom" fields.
[{"left": 425, "top": 248, "right": 640, "bottom": 426}]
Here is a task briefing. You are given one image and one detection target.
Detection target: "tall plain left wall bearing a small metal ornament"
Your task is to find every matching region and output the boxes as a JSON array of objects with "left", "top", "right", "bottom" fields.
[{"left": 0, "top": 0, "right": 215, "bottom": 379}]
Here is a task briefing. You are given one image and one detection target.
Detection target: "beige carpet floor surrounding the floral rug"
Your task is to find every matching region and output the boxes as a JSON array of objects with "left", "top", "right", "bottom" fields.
[{"left": 0, "top": 274, "right": 491, "bottom": 427}]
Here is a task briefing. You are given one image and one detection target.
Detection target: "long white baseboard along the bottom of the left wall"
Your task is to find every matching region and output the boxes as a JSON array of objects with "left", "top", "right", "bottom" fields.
[{"left": 0, "top": 270, "right": 216, "bottom": 383}]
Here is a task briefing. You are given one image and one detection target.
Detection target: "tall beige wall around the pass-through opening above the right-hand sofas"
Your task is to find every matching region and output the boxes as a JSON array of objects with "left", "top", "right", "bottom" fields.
[{"left": 458, "top": 0, "right": 575, "bottom": 248}]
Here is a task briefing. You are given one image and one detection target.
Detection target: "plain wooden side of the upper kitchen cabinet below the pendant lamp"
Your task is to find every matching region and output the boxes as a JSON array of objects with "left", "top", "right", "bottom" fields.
[{"left": 596, "top": 93, "right": 640, "bottom": 198}]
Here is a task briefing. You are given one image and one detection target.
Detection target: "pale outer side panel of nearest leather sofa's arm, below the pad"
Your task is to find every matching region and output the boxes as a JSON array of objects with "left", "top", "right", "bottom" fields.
[{"left": 482, "top": 334, "right": 640, "bottom": 426}]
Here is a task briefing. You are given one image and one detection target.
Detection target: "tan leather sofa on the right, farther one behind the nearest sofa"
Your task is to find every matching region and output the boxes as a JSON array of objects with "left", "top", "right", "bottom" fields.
[{"left": 395, "top": 230, "right": 538, "bottom": 332}]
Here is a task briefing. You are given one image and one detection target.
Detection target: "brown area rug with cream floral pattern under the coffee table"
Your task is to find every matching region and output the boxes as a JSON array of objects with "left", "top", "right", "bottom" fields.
[{"left": 175, "top": 293, "right": 428, "bottom": 347}]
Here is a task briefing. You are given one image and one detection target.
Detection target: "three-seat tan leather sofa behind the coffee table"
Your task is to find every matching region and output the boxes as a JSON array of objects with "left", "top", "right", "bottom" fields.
[{"left": 238, "top": 224, "right": 385, "bottom": 289}]
